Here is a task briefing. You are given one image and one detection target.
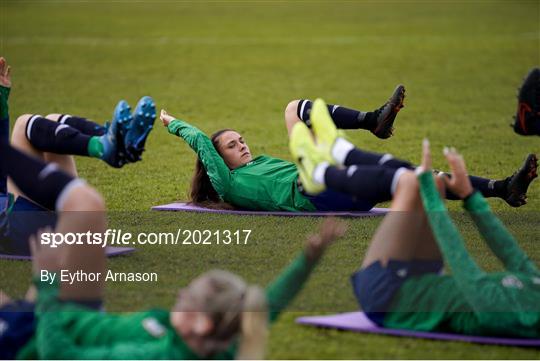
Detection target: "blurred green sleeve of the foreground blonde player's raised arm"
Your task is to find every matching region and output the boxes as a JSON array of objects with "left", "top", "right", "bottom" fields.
[{"left": 266, "top": 252, "right": 316, "bottom": 322}]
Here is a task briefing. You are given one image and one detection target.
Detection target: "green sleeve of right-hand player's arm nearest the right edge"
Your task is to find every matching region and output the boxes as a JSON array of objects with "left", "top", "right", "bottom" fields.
[{"left": 464, "top": 192, "right": 540, "bottom": 275}]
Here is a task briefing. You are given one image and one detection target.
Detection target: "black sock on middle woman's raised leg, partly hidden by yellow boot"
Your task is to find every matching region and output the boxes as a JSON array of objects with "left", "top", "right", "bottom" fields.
[{"left": 296, "top": 99, "right": 377, "bottom": 130}]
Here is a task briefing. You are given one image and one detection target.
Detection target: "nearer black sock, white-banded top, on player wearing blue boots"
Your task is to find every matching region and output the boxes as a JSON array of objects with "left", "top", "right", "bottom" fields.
[{"left": 26, "top": 115, "right": 91, "bottom": 155}]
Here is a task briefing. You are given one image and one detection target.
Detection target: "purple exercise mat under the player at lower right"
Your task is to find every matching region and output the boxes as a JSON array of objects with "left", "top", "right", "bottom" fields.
[{"left": 296, "top": 312, "right": 540, "bottom": 347}]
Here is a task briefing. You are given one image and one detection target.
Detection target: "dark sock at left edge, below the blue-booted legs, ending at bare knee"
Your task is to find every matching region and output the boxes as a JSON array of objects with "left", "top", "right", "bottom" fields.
[{"left": 0, "top": 143, "right": 76, "bottom": 210}]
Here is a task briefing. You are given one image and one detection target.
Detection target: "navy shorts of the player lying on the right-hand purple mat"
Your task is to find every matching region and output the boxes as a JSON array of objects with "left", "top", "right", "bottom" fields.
[{"left": 351, "top": 260, "right": 443, "bottom": 326}]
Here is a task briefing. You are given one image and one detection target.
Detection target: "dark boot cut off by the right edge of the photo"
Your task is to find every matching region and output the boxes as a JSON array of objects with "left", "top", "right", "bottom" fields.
[{"left": 513, "top": 68, "right": 540, "bottom": 135}]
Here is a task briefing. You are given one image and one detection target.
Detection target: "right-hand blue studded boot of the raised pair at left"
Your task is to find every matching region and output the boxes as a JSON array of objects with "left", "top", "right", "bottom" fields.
[{"left": 125, "top": 96, "right": 156, "bottom": 162}]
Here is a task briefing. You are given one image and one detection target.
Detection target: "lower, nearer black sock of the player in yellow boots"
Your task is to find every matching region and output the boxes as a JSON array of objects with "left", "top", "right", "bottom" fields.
[{"left": 324, "top": 165, "right": 405, "bottom": 203}]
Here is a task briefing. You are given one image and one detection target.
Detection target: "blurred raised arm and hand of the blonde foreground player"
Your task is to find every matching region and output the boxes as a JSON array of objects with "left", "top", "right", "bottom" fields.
[{"left": 266, "top": 218, "right": 346, "bottom": 322}]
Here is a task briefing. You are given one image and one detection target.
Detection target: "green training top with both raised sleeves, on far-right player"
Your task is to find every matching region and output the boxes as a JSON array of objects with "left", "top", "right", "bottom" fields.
[{"left": 383, "top": 173, "right": 540, "bottom": 338}]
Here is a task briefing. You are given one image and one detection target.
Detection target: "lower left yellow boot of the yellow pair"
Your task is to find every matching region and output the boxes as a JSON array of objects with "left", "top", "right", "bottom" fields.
[{"left": 289, "top": 122, "right": 330, "bottom": 194}]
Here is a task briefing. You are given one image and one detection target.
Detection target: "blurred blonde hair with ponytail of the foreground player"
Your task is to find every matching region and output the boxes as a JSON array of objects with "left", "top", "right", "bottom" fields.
[{"left": 188, "top": 270, "right": 268, "bottom": 359}]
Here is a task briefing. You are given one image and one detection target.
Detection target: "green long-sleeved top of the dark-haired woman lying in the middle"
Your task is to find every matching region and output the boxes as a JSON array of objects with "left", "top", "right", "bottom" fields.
[{"left": 168, "top": 119, "right": 316, "bottom": 212}]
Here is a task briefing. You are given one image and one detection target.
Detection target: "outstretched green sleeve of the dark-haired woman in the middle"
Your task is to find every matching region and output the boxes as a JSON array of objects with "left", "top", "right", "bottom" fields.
[{"left": 167, "top": 119, "right": 231, "bottom": 198}]
